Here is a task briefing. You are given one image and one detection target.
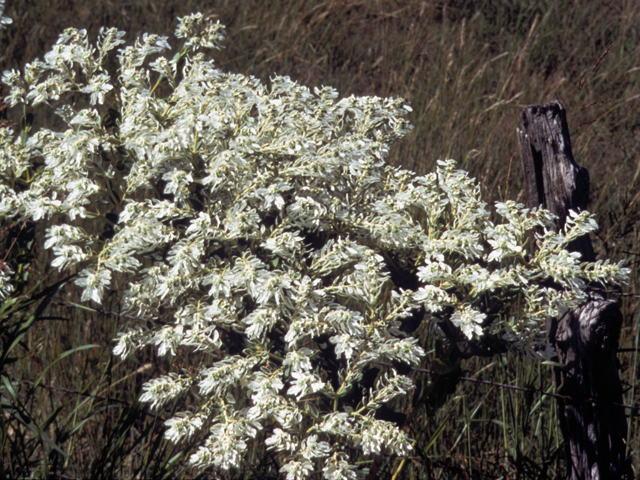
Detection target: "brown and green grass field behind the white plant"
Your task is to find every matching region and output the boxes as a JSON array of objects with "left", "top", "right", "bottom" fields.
[{"left": 0, "top": 0, "right": 640, "bottom": 479}]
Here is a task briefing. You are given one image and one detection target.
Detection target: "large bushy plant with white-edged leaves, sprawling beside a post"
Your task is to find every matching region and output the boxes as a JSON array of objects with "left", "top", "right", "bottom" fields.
[{"left": 0, "top": 14, "right": 628, "bottom": 480}]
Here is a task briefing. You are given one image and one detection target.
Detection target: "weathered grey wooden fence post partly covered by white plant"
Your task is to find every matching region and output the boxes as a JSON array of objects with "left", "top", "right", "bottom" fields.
[{"left": 518, "top": 101, "right": 633, "bottom": 480}]
